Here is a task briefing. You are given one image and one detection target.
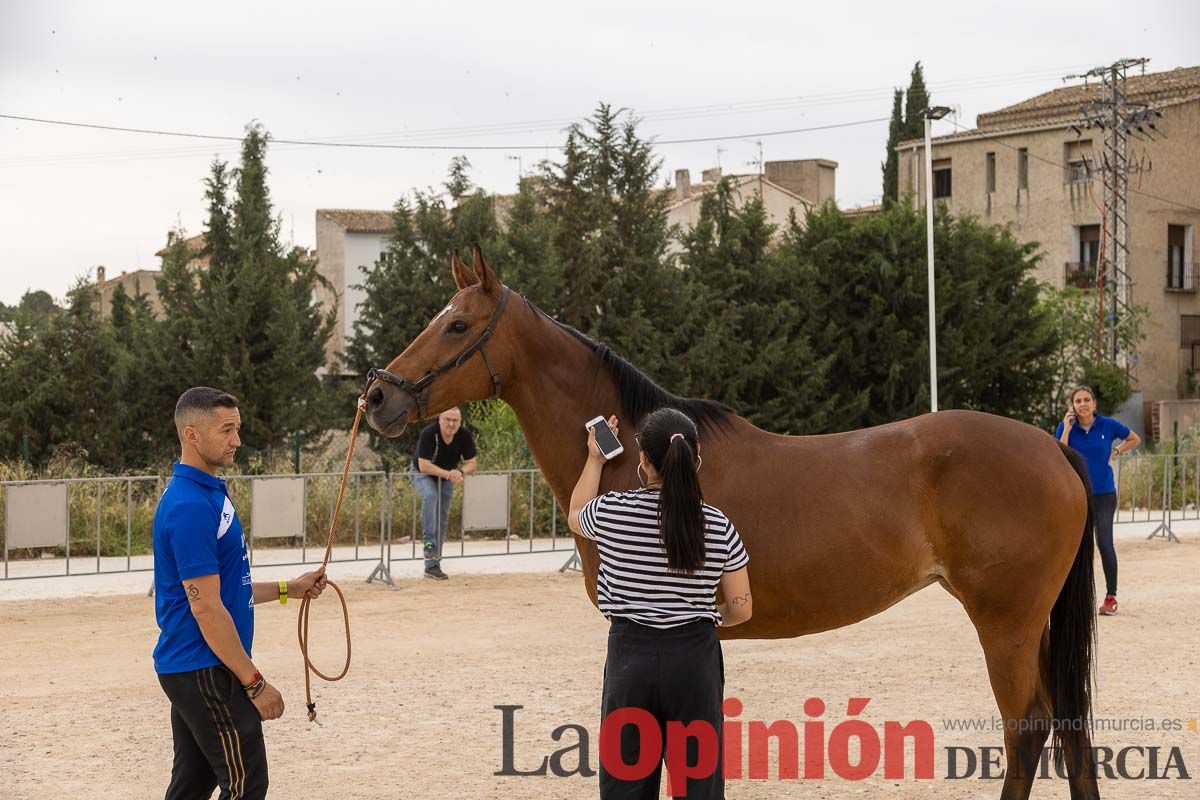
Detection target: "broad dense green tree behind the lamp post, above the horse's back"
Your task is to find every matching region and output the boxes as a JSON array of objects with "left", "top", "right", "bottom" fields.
[{"left": 781, "top": 203, "right": 1056, "bottom": 429}]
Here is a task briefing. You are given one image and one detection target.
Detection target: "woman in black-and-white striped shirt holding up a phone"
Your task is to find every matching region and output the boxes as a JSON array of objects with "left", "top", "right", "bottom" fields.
[{"left": 568, "top": 408, "right": 752, "bottom": 799}]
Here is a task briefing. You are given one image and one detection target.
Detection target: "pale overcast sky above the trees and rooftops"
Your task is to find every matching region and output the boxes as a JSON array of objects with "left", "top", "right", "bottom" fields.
[{"left": 0, "top": 0, "right": 1200, "bottom": 303}]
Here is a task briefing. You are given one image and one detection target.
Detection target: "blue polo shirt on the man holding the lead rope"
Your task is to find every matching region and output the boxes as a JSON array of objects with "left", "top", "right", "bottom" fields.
[{"left": 154, "top": 462, "right": 254, "bottom": 674}]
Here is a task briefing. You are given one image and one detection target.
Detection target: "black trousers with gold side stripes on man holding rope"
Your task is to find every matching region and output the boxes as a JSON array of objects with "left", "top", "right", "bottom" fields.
[{"left": 158, "top": 667, "right": 268, "bottom": 800}]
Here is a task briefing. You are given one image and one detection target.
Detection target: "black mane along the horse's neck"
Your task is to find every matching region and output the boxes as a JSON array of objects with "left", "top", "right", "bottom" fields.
[{"left": 523, "top": 297, "right": 734, "bottom": 433}]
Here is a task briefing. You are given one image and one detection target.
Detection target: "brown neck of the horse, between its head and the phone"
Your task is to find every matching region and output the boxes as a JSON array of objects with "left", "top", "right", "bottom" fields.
[{"left": 502, "top": 307, "right": 632, "bottom": 509}]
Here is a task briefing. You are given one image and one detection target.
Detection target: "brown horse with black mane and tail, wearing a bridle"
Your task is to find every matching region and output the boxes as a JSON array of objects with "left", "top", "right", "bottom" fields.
[{"left": 367, "top": 247, "right": 1099, "bottom": 799}]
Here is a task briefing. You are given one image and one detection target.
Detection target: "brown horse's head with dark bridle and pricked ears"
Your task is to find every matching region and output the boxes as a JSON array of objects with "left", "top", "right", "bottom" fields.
[{"left": 366, "top": 245, "right": 512, "bottom": 437}]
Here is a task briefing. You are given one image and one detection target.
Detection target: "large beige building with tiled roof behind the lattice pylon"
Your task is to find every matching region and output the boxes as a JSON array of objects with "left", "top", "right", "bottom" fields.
[{"left": 896, "top": 67, "right": 1200, "bottom": 427}]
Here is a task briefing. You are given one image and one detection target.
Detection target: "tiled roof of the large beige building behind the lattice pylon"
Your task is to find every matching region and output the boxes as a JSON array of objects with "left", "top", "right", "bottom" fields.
[{"left": 896, "top": 67, "right": 1200, "bottom": 149}]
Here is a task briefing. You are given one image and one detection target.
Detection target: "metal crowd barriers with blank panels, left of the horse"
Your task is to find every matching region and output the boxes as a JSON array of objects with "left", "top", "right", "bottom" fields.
[{"left": 0, "top": 469, "right": 574, "bottom": 585}]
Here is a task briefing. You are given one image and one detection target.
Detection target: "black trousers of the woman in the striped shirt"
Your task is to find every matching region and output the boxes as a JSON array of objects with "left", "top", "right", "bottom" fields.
[{"left": 600, "top": 618, "right": 725, "bottom": 800}]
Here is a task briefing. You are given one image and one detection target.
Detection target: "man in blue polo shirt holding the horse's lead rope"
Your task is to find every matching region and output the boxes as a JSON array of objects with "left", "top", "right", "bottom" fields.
[{"left": 154, "top": 386, "right": 325, "bottom": 800}]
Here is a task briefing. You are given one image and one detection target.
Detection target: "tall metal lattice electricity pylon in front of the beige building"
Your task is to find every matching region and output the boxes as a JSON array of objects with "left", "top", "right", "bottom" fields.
[{"left": 1064, "top": 59, "right": 1163, "bottom": 376}]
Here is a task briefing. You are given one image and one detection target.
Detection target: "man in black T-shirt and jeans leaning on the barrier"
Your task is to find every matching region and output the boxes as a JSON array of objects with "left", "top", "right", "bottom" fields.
[{"left": 413, "top": 408, "right": 475, "bottom": 581}]
